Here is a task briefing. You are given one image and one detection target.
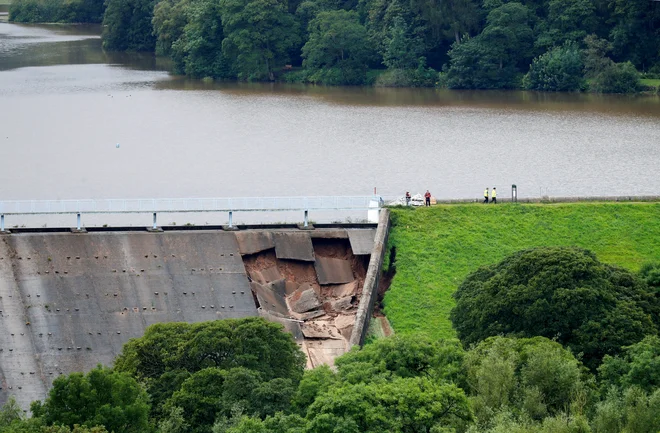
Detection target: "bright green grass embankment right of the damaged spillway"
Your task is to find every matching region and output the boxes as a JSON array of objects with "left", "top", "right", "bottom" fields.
[{"left": 384, "top": 202, "right": 660, "bottom": 338}]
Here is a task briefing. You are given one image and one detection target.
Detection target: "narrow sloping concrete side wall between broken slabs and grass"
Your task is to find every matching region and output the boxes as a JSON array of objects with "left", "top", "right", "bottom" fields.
[{"left": 349, "top": 209, "right": 390, "bottom": 346}]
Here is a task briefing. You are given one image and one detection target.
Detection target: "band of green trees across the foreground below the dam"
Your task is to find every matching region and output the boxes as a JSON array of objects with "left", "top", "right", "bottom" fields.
[{"left": 0, "top": 247, "right": 660, "bottom": 433}]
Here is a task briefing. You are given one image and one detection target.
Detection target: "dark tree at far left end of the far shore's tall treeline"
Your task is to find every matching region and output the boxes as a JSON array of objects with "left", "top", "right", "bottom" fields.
[{"left": 102, "top": 0, "right": 156, "bottom": 51}]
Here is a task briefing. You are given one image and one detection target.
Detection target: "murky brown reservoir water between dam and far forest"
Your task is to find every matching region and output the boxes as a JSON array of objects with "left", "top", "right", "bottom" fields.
[{"left": 0, "top": 22, "right": 660, "bottom": 211}]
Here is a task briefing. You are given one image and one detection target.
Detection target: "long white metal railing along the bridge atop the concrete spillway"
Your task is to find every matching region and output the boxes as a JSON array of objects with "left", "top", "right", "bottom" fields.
[{"left": 0, "top": 195, "right": 383, "bottom": 231}]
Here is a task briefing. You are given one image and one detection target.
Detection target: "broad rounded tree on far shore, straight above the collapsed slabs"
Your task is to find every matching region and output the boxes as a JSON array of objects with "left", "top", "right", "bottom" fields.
[{"left": 302, "top": 10, "right": 373, "bottom": 84}]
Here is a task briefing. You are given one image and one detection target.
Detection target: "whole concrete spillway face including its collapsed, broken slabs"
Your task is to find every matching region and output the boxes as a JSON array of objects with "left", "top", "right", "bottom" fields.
[{"left": 0, "top": 228, "right": 375, "bottom": 408}]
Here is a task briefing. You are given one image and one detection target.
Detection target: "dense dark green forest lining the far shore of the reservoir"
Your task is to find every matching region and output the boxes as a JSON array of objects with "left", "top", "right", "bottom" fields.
[{"left": 10, "top": 0, "right": 660, "bottom": 93}]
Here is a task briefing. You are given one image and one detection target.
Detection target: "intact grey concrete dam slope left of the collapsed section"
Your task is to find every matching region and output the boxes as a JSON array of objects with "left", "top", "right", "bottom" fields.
[{"left": 0, "top": 231, "right": 257, "bottom": 408}]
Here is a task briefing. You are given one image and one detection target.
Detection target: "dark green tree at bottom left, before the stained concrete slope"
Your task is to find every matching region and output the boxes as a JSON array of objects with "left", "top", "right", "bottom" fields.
[{"left": 32, "top": 366, "right": 149, "bottom": 433}]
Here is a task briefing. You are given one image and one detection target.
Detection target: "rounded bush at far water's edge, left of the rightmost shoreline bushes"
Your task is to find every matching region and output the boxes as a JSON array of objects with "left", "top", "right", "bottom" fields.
[{"left": 523, "top": 45, "right": 584, "bottom": 92}]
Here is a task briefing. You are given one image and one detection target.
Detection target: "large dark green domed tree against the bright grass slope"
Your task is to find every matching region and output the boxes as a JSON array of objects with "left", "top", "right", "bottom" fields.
[{"left": 451, "top": 247, "right": 660, "bottom": 369}]
